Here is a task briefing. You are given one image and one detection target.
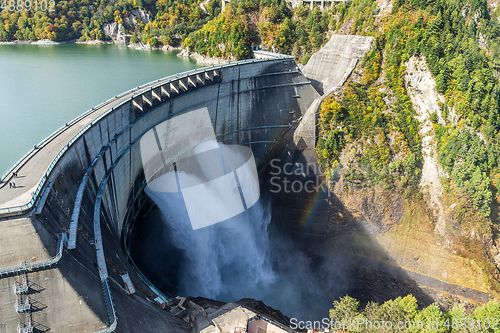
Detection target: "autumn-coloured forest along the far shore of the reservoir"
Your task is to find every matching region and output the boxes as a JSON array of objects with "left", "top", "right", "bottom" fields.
[{"left": 0, "top": 0, "right": 336, "bottom": 63}]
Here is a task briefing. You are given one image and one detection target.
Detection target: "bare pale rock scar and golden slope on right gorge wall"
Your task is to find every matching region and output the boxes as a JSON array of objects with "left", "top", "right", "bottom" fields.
[{"left": 314, "top": 50, "right": 491, "bottom": 308}]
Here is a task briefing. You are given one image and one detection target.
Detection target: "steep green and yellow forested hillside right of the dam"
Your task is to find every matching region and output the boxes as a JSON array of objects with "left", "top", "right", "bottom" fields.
[{"left": 317, "top": 0, "right": 500, "bottom": 296}]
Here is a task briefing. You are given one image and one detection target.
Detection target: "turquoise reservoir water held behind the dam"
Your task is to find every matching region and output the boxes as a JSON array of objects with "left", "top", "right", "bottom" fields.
[{"left": 0, "top": 44, "right": 201, "bottom": 174}]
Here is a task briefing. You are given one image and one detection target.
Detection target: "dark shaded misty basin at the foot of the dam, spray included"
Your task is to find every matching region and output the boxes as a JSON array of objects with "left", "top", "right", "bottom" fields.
[{"left": 129, "top": 142, "right": 433, "bottom": 320}]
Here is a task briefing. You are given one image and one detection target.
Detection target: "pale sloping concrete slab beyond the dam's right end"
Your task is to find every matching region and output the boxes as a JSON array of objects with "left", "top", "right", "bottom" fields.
[{"left": 303, "top": 35, "right": 373, "bottom": 95}]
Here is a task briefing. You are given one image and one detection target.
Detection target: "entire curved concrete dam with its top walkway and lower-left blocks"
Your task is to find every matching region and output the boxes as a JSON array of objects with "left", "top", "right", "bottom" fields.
[{"left": 0, "top": 56, "right": 321, "bottom": 332}]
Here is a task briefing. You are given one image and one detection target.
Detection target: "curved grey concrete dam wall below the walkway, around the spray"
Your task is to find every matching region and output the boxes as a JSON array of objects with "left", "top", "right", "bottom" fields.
[{"left": 11, "top": 57, "right": 318, "bottom": 332}]
